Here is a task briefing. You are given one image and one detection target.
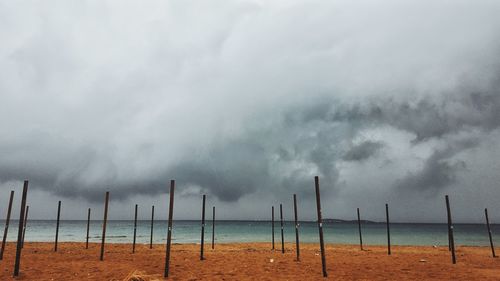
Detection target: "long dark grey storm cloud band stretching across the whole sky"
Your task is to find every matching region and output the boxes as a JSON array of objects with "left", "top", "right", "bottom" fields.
[{"left": 0, "top": 85, "right": 500, "bottom": 201}]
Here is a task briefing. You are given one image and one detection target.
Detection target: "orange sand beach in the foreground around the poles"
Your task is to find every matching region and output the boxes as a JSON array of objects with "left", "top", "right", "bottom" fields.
[{"left": 0, "top": 243, "right": 500, "bottom": 280}]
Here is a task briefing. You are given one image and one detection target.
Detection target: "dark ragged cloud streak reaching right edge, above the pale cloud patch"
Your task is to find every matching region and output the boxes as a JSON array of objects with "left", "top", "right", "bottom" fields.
[{"left": 301, "top": 89, "right": 500, "bottom": 142}]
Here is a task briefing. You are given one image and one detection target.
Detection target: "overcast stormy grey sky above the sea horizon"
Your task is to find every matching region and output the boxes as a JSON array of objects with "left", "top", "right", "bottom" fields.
[{"left": 0, "top": 0, "right": 500, "bottom": 222}]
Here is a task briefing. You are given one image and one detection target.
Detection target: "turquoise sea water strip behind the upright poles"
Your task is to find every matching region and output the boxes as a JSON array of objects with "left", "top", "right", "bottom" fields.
[{"left": 0, "top": 220, "right": 500, "bottom": 246}]
